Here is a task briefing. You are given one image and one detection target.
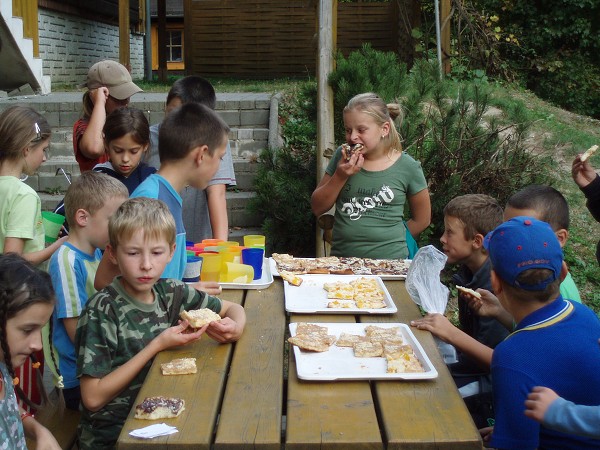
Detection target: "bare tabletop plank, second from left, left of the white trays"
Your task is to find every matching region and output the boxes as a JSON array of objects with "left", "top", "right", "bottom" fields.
[{"left": 214, "top": 279, "right": 286, "bottom": 450}]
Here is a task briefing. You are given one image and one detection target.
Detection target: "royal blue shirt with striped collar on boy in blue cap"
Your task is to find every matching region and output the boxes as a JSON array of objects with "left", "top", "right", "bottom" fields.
[{"left": 491, "top": 296, "right": 600, "bottom": 450}]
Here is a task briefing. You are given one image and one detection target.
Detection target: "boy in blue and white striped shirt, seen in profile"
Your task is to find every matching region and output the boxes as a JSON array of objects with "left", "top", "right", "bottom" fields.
[{"left": 44, "top": 172, "right": 129, "bottom": 410}]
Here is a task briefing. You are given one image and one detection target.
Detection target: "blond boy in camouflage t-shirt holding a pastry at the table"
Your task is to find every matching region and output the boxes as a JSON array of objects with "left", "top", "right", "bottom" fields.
[{"left": 75, "top": 197, "right": 246, "bottom": 450}]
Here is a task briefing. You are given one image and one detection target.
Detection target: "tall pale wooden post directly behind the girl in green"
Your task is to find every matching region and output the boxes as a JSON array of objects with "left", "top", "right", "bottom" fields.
[{"left": 316, "top": 0, "right": 337, "bottom": 256}]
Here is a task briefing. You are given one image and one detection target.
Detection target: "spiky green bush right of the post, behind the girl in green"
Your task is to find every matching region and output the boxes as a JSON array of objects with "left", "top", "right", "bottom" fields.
[{"left": 329, "top": 46, "right": 547, "bottom": 244}]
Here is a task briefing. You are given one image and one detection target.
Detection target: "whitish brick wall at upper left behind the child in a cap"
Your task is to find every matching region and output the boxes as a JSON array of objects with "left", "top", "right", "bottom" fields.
[{"left": 38, "top": 8, "right": 144, "bottom": 89}]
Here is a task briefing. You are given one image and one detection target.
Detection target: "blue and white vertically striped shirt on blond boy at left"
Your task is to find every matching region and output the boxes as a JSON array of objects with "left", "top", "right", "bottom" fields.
[{"left": 44, "top": 242, "right": 102, "bottom": 389}]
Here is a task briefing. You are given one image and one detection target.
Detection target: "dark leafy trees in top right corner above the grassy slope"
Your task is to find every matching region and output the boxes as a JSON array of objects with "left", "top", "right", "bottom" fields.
[{"left": 452, "top": 0, "right": 600, "bottom": 117}]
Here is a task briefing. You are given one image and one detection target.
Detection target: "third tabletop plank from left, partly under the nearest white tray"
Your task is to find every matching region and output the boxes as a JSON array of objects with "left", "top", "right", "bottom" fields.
[{"left": 285, "top": 314, "right": 384, "bottom": 449}]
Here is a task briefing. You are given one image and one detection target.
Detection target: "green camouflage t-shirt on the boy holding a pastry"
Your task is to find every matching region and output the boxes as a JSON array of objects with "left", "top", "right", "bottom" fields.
[{"left": 75, "top": 277, "right": 222, "bottom": 450}]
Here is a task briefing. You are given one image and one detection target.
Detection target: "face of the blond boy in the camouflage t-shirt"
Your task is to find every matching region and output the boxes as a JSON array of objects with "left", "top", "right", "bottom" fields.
[{"left": 108, "top": 230, "right": 175, "bottom": 300}]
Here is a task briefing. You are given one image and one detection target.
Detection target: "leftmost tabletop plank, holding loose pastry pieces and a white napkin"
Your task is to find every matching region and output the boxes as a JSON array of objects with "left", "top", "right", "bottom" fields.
[{"left": 117, "top": 290, "right": 244, "bottom": 450}]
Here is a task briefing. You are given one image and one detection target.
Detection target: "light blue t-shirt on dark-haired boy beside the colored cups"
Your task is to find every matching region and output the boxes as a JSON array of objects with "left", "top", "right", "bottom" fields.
[{"left": 131, "top": 173, "right": 187, "bottom": 280}]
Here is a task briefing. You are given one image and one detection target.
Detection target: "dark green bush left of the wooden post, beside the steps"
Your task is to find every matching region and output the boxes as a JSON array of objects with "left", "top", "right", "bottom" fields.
[{"left": 248, "top": 83, "right": 317, "bottom": 256}]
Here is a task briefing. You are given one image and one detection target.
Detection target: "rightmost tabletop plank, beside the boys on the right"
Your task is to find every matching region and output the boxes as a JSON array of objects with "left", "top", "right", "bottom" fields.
[{"left": 361, "top": 281, "right": 483, "bottom": 450}]
